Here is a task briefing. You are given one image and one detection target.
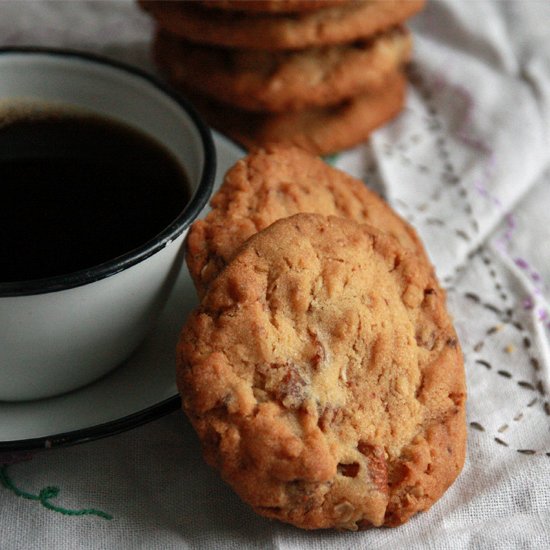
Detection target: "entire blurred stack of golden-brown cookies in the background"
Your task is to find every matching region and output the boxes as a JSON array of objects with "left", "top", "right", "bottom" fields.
[{"left": 140, "top": 0, "right": 424, "bottom": 154}]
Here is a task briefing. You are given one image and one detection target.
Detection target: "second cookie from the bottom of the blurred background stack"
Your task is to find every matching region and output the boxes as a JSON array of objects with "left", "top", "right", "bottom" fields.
[{"left": 154, "top": 29, "right": 412, "bottom": 112}]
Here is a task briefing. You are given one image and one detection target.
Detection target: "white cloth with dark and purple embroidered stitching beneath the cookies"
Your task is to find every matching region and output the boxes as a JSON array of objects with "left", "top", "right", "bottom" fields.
[{"left": 0, "top": 0, "right": 550, "bottom": 550}]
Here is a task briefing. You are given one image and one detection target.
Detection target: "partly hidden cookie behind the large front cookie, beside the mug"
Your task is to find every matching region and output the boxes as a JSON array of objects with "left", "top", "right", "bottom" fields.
[{"left": 186, "top": 146, "right": 429, "bottom": 295}]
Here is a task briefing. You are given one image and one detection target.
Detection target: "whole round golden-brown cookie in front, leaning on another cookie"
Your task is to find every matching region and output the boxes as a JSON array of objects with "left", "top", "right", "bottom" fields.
[{"left": 177, "top": 214, "right": 466, "bottom": 530}]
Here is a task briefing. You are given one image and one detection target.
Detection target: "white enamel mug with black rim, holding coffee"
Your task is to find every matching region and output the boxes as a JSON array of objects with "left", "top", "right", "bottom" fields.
[{"left": 0, "top": 48, "right": 216, "bottom": 401}]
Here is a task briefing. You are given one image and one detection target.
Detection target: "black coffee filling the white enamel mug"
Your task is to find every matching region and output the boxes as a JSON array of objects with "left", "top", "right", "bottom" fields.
[{"left": 0, "top": 112, "right": 190, "bottom": 282}]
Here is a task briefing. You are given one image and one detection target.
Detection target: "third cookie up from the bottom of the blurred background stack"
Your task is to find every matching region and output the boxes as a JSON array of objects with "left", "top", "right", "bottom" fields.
[{"left": 139, "top": 0, "right": 425, "bottom": 50}]
